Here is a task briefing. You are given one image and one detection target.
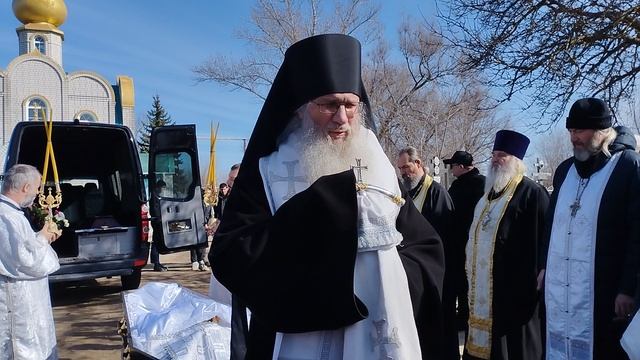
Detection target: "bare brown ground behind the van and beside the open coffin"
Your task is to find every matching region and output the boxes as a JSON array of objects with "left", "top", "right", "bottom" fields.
[{"left": 52, "top": 251, "right": 210, "bottom": 360}]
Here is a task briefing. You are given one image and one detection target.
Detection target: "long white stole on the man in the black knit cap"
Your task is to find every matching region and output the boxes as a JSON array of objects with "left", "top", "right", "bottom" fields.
[{"left": 545, "top": 153, "right": 620, "bottom": 360}]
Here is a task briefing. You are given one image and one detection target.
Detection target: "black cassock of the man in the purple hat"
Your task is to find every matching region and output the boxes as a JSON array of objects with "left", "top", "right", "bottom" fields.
[{"left": 464, "top": 177, "right": 549, "bottom": 359}]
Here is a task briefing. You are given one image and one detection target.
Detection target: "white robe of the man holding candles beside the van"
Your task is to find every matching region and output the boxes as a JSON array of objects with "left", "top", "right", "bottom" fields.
[{"left": 0, "top": 195, "right": 60, "bottom": 360}]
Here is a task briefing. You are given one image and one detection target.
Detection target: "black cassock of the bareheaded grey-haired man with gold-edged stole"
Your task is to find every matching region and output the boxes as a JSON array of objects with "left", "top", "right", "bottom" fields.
[{"left": 409, "top": 177, "right": 464, "bottom": 359}]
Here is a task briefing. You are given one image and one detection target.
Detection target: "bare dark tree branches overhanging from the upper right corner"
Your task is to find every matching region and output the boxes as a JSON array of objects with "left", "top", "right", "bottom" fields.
[{"left": 439, "top": 0, "right": 640, "bottom": 125}]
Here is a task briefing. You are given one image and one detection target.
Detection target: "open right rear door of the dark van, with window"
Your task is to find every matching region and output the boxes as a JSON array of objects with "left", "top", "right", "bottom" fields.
[{"left": 149, "top": 125, "right": 207, "bottom": 254}]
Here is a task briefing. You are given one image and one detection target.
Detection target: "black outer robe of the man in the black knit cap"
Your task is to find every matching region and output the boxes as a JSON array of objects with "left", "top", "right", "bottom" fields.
[{"left": 541, "top": 150, "right": 640, "bottom": 359}]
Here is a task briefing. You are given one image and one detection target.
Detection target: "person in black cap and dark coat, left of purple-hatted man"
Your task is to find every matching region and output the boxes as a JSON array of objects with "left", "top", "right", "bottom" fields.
[{"left": 442, "top": 150, "right": 485, "bottom": 332}]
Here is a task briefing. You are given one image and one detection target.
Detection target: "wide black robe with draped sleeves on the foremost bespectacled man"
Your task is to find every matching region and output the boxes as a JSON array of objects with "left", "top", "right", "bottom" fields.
[{"left": 209, "top": 165, "right": 444, "bottom": 359}]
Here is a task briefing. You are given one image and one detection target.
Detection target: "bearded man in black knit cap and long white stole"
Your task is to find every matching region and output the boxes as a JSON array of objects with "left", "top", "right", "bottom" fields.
[{"left": 541, "top": 98, "right": 640, "bottom": 359}]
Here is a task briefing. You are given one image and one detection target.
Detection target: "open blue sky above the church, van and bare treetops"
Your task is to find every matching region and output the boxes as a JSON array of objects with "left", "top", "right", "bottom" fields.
[{"left": 0, "top": 0, "right": 433, "bottom": 181}]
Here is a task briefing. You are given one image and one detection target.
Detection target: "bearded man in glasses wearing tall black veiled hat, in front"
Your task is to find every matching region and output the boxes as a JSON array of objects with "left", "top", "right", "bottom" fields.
[{"left": 210, "top": 34, "right": 444, "bottom": 359}]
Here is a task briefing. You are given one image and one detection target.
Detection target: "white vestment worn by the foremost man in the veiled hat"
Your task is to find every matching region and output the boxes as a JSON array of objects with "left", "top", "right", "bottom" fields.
[{"left": 260, "top": 128, "right": 421, "bottom": 360}]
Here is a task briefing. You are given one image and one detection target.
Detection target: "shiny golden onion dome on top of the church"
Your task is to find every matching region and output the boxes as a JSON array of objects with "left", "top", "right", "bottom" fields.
[{"left": 12, "top": 0, "right": 67, "bottom": 26}]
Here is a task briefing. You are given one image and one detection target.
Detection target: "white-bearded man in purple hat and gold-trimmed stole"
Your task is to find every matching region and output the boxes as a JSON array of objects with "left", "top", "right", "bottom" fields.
[{"left": 463, "top": 130, "right": 549, "bottom": 360}]
